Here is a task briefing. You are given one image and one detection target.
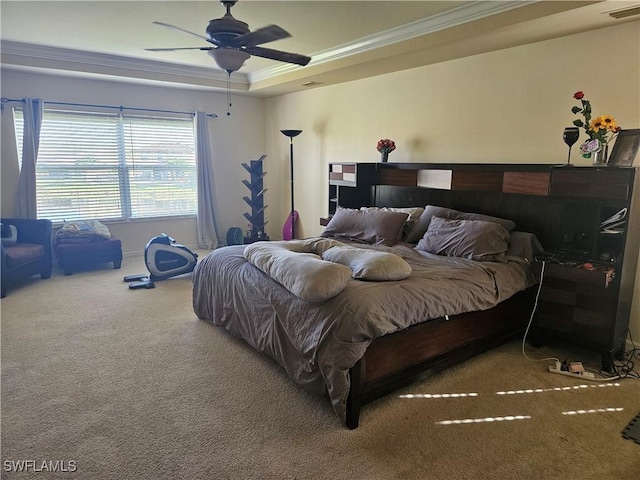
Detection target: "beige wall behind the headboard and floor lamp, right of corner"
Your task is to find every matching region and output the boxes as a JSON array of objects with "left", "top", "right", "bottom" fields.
[{"left": 265, "top": 22, "right": 640, "bottom": 342}]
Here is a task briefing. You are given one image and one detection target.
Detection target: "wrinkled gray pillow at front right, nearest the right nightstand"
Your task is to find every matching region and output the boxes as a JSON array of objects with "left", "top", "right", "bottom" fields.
[{"left": 416, "top": 217, "right": 509, "bottom": 262}]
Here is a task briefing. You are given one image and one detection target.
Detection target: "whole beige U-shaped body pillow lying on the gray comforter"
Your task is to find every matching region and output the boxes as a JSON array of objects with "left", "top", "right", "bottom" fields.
[{"left": 244, "top": 238, "right": 411, "bottom": 302}]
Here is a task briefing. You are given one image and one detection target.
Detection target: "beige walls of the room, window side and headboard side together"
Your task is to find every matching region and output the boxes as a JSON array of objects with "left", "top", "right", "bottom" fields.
[{"left": 1, "top": 22, "right": 640, "bottom": 341}]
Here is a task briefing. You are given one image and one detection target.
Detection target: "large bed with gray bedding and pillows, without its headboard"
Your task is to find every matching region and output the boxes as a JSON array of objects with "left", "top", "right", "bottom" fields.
[{"left": 193, "top": 205, "right": 541, "bottom": 429}]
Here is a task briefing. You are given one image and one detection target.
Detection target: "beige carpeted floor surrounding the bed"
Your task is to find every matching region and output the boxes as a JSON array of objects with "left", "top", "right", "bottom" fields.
[{"left": 1, "top": 252, "right": 640, "bottom": 480}]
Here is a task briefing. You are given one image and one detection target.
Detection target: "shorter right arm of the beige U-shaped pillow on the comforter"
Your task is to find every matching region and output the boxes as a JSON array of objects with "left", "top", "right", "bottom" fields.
[{"left": 322, "top": 247, "right": 411, "bottom": 281}]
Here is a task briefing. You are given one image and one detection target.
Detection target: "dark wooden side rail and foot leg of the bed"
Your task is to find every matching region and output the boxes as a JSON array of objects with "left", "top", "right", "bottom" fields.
[{"left": 345, "top": 287, "right": 535, "bottom": 429}]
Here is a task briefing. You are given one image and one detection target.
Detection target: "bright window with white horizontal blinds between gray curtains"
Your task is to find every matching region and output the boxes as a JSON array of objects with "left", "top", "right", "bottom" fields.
[{"left": 14, "top": 109, "right": 197, "bottom": 222}]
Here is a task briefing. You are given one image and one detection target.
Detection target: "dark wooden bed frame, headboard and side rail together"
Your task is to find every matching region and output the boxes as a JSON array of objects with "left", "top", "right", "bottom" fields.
[{"left": 340, "top": 163, "right": 576, "bottom": 429}]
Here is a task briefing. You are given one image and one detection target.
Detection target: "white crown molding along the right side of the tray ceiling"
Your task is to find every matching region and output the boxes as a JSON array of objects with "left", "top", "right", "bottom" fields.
[{"left": 248, "top": 0, "right": 538, "bottom": 84}]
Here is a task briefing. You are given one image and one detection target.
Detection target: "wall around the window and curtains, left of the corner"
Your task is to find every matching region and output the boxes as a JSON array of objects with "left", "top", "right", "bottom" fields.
[{"left": 0, "top": 71, "right": 265, "bottom": 251}]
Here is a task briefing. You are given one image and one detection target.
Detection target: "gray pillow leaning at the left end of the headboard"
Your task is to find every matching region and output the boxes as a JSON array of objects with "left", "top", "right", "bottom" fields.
[{"left": 322, "top": 208, "right": 408, "bottom": 246}]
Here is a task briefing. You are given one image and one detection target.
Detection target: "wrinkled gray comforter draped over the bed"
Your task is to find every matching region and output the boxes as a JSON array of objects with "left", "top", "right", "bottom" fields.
[{"left": 193, "top": 239, "right": 533, "bottom": 421}]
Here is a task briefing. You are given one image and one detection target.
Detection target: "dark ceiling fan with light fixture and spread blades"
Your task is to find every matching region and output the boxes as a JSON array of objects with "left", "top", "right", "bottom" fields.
[{"left": 145, "top": 0, "right": 311, "bottom": 75}]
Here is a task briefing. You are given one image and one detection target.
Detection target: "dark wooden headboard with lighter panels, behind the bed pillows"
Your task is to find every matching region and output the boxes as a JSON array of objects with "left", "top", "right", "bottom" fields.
[{"left": 329, "top": 163, "right": 639, "bottom": 256}]
